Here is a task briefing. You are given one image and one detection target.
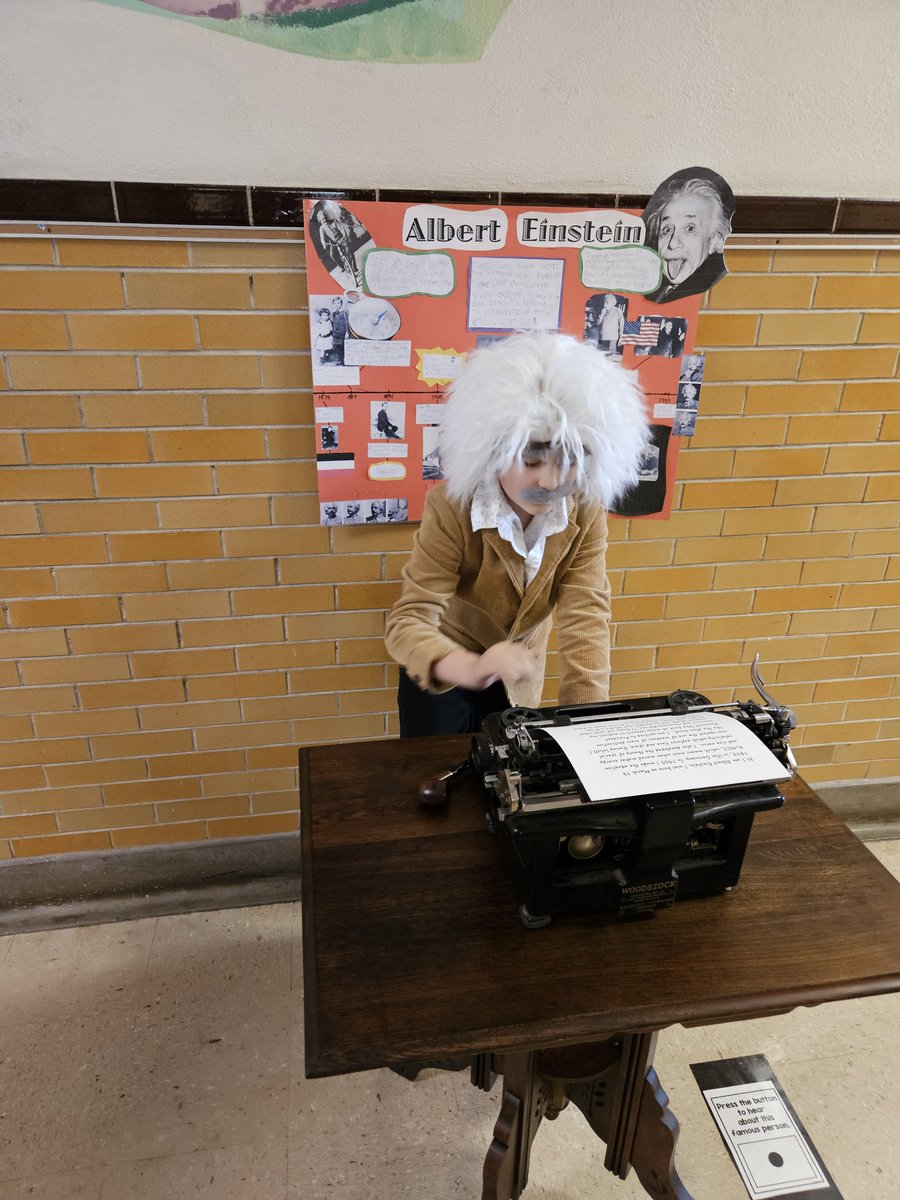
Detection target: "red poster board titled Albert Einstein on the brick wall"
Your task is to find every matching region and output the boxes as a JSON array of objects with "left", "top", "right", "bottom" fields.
[{"left": 305, "top": 167, "right": 733, "bottom": 524}]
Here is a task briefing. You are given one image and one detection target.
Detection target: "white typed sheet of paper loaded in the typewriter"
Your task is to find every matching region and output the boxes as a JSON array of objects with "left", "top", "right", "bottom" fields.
[{"left": 547, "top": 713, "right": 791, "bottom": 800}]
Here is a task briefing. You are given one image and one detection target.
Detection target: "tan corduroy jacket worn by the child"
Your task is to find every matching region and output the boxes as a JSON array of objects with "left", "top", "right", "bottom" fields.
[{"left": 385, "top": 487, "right": 610, "bottom": 707}]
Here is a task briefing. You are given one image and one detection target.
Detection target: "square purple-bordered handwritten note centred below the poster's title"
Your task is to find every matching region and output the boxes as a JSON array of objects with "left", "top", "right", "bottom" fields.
[{"left": 468, "top": 257, "right": 565, "bottom": 330}]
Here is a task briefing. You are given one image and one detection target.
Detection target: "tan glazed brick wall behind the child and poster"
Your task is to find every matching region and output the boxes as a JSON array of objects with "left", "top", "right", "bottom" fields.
[{"left": 0, "top": 229, "right": 900, "bottom": 857}]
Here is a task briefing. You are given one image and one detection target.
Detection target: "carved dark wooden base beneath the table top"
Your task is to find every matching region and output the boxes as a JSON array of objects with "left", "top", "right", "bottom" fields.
[{"left": 480, "top": 1033, "right": 691, "bottom": 1200}]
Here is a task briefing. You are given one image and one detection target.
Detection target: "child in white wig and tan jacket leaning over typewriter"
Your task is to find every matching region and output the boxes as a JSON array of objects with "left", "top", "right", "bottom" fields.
[{"left": 385, "top": 332, "right": 647, "bottom": 737}]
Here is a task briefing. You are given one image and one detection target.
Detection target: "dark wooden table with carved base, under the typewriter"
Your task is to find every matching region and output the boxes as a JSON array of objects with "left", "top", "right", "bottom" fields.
[{"left": 300, "top": 737, "right": 900, "bottom": 1200}]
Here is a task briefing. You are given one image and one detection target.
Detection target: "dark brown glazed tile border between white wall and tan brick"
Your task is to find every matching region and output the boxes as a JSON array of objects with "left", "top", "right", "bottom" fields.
[{"left": 0, "top": 179, "right": 900, "bottom": 234}]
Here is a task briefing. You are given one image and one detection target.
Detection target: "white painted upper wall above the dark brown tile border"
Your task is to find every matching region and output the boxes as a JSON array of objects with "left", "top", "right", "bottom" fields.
[{"left": 0, "top": 0, "right": 900, "bottom": 198}]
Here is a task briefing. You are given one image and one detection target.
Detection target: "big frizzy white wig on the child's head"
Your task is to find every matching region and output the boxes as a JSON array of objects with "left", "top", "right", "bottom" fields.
[{"left": 438, "top": 331, "right": 648, "bottom": 509}]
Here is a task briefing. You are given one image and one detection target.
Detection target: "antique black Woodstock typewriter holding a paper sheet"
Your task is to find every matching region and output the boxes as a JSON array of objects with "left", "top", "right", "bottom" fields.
[{"left": 420, "top": 660, "right": 796, "bottom": 929}]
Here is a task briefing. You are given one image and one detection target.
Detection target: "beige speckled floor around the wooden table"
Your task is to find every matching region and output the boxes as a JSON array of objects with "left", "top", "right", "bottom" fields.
[{"left": 0, "top": 841, "right": 900, "bottom": 1200}]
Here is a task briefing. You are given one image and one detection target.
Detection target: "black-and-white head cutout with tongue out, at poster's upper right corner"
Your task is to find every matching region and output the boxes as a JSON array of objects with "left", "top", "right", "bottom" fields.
[{"left": 643, "top": 167, "right": 734, "bottom": 304}]
